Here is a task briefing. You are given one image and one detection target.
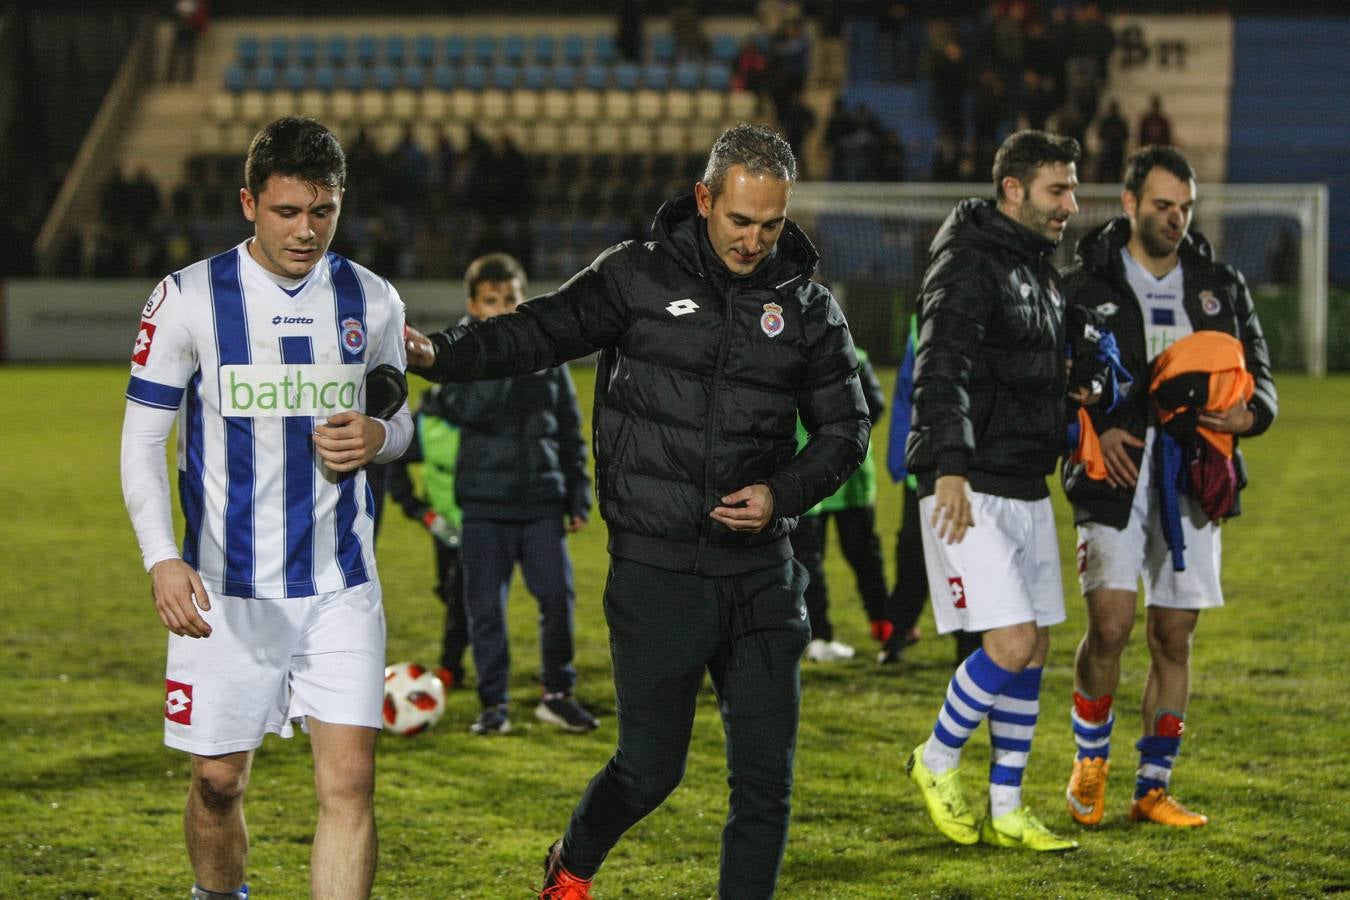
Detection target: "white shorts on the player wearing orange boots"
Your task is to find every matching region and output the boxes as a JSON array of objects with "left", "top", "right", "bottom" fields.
[{"left": 1077, "top": 428, "right": 1223, "bottom": 610}]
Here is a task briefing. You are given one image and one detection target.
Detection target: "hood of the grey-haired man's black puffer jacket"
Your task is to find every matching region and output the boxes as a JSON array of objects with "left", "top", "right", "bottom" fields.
[{"left": 652, "top": 194, "right": 821, "bottom": 289}]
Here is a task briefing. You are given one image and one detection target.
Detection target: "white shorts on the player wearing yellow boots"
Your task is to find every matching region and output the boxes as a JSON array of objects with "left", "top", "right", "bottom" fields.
[{"left": 919, "top": 491, "right": 1065, "bottom": 634}]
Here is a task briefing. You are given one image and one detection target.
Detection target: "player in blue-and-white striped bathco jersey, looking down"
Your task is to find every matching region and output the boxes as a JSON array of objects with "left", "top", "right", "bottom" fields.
[{"left": 122, "top": 119, "right": 412, "bottom": 899}]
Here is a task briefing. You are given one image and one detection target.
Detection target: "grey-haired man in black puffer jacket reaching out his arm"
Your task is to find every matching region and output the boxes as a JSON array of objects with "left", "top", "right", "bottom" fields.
[{"left": 408, "top": 125, "right": 869, "bottom": 899}]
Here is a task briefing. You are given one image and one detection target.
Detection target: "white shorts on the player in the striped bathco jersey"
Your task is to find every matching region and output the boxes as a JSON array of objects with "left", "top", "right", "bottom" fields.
[{"left": 165, "top": 580, "right": 385, "bottom": 756}]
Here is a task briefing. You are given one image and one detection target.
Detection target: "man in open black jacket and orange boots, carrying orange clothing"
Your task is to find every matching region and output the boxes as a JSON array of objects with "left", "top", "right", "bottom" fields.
[{"left": 1064, "top": 147, "right": 1278, "bottom": 827}]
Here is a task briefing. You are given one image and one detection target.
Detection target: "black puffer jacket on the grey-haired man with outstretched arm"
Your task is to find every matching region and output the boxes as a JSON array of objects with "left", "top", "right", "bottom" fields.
[{"left": 415, "top": 197, "right": 869, "bottom": 575}]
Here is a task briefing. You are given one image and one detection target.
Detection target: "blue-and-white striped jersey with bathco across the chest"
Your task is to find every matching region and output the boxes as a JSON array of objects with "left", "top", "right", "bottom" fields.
[{"left": 127, "top": 242, "right": 406, "bottom": 598}]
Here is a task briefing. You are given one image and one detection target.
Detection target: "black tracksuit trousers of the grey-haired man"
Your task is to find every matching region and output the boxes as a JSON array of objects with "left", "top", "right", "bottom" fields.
[{"left": 563, "top": 559, "right": 810, "bottom": 900}]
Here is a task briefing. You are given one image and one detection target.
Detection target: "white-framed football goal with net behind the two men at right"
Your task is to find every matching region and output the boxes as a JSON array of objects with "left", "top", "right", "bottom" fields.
[{"left": 790, "top": 182, "right": 1328, "bottom": 375}]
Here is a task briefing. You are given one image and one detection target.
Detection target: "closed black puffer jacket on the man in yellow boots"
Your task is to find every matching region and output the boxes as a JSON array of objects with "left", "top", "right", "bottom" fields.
[{"left": 905, "top": 200, "right": 1068, "bottom": 499}]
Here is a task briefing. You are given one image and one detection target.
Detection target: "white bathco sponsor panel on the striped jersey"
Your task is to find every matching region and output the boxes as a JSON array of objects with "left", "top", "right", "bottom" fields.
[{"left": 220, "top": 364, "right": 366, "bottom": 418}]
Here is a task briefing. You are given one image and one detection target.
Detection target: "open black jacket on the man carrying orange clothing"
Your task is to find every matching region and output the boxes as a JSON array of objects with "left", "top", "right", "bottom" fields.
[{"left": 1062, "top": 216, "right": 1278, "bottom": 528}]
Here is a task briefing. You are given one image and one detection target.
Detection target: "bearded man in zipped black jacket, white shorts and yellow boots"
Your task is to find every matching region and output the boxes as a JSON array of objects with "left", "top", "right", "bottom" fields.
[{"left": 906, "top": 131, "right": 1085, "bottom": 851}]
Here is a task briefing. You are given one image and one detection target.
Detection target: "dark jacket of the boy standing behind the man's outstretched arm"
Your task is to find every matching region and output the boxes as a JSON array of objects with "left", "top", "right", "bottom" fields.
[{"left": 427, "top": 318, "right": 590, "bottom": 522}]
